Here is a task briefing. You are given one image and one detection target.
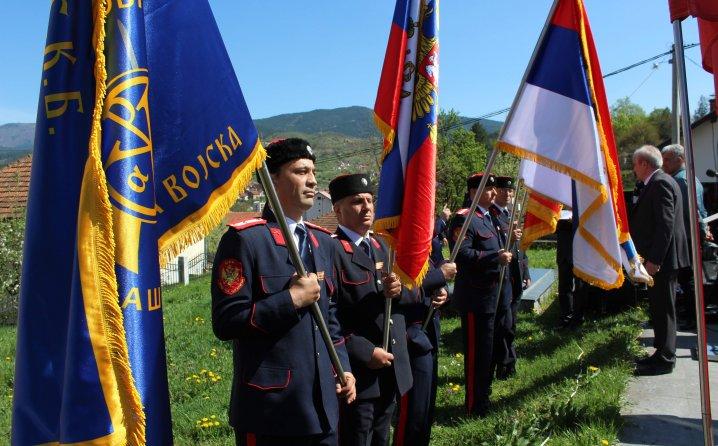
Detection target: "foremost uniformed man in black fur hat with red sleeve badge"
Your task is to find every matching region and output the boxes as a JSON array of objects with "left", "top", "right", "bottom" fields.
[{"left": 212, "top": 138, "right": 355, "bottom": 445}]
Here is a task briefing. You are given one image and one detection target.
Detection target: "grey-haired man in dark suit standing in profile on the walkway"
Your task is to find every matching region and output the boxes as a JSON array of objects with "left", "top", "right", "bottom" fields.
[{"left": 629, "top": 146, "right": 690, "bottom": 375}]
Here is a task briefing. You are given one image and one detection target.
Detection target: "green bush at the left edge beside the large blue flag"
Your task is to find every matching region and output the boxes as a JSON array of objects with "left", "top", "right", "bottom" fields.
[{"left": 0, "top": 213, "right": 25, "bottom": 325}]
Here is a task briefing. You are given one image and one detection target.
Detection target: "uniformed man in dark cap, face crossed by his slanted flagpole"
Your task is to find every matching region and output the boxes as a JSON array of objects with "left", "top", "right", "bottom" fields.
[{"left": 449, "top": 173, "right": 512, "bottom": 417}]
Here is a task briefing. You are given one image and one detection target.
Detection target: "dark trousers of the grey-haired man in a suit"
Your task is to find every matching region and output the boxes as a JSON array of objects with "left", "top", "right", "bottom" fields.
[{"left": 647, "top": 271, "right": 677, "bottom": 363}]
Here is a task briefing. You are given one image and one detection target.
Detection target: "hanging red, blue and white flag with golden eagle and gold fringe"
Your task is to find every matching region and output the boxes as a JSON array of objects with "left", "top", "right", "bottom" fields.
[{"left": 374, "top": 0, "right": 439, "bottom": 287}]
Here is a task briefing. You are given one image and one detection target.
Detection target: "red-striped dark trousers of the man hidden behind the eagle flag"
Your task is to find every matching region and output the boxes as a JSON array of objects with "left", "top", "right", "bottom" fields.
[{"left": 394, "top": 316, "right": 439, "bottom": 446}]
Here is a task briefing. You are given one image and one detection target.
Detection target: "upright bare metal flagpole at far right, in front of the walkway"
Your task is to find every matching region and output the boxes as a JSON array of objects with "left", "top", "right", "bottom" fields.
[{"left": 673, "top": 20, "right": 713, "bottom": 446}]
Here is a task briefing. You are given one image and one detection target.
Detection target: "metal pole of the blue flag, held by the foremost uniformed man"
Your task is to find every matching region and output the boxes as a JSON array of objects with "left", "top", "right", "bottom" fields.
[{"left": 258, "top": 162, "right": 347, "bottom": 386}]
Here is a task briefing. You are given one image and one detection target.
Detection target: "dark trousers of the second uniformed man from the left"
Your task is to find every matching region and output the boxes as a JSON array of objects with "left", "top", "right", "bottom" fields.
[{"left": 339, "top": 369, "right": 397, "bottom": 446}]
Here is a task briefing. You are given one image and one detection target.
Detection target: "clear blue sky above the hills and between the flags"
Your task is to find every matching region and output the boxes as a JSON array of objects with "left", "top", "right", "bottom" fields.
[{"left": 0, "top": 0, "right": 713, "bottom": 124}]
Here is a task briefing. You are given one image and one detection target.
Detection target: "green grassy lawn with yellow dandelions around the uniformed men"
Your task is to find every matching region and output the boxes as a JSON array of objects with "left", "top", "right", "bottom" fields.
[{"left": 0, "top": 253, "right": 643, "bottom": 446}]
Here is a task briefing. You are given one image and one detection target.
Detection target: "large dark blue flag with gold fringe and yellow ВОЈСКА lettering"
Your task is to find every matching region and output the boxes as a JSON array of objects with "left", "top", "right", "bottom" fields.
[{"left": 12, "top": 0, "right": 265, "bottom": 445}]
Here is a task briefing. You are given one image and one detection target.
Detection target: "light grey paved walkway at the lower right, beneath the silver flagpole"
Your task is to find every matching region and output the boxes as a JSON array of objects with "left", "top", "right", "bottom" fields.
[{"left": 619, "top": 325, "right": 718, "bottom": 446}]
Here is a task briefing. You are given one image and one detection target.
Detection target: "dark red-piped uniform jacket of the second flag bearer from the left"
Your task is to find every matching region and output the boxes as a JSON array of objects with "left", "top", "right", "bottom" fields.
[{"left": 335, "top": 228, "right": 413, "bottom": 399}]
